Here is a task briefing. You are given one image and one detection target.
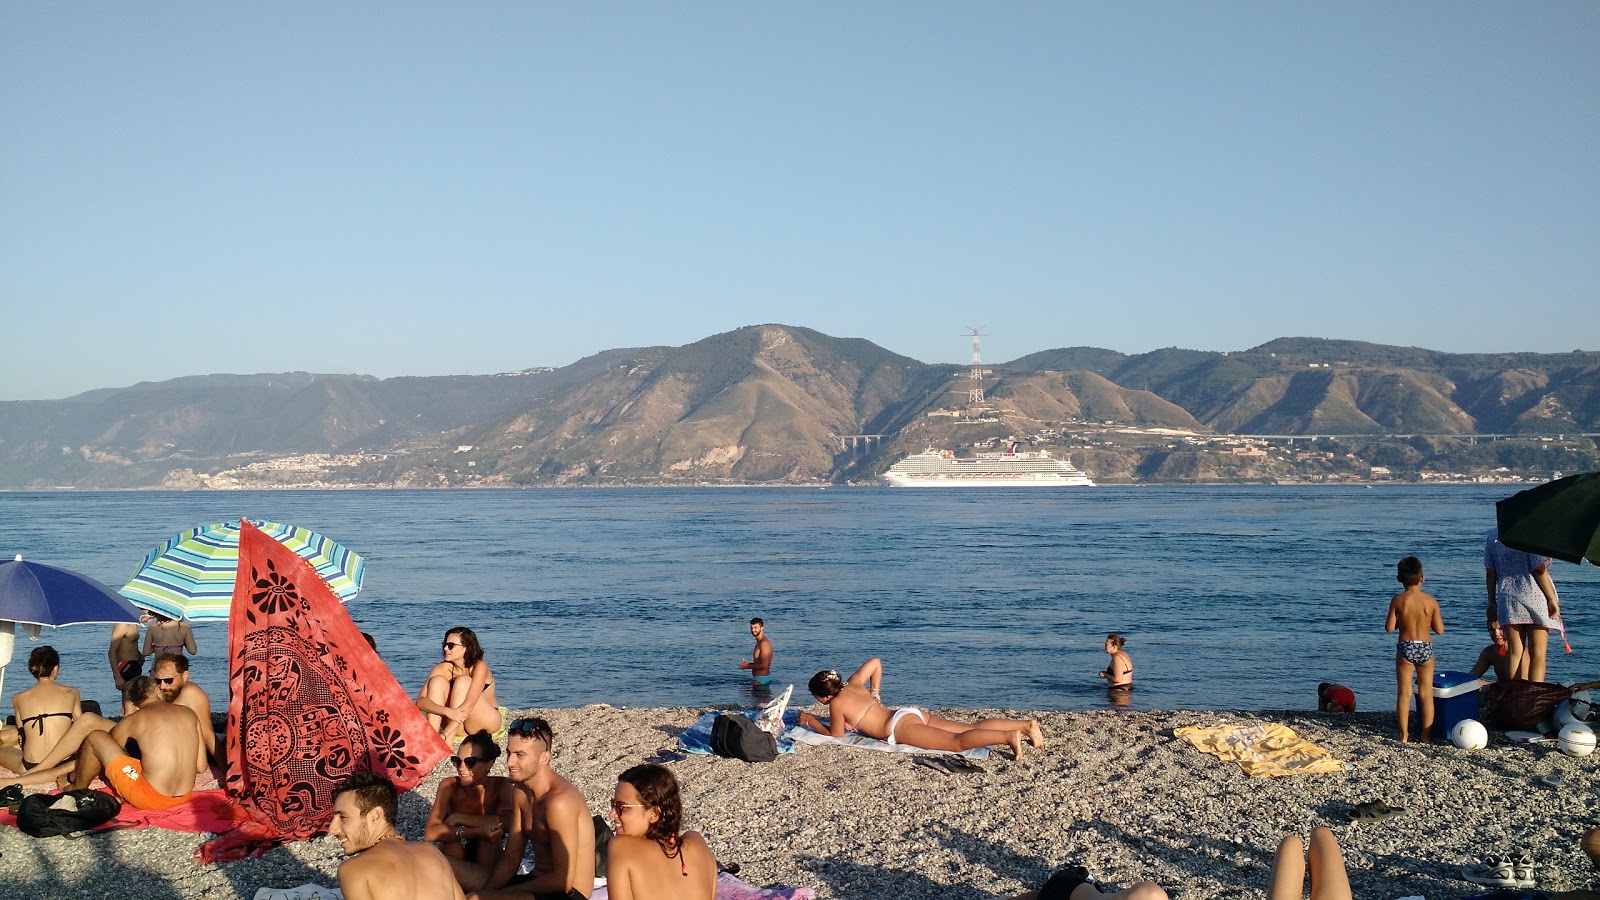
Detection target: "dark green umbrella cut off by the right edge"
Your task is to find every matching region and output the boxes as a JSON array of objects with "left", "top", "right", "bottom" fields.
[{"left": 1494, "top": 472, "right": 1600, "bottom": 565}]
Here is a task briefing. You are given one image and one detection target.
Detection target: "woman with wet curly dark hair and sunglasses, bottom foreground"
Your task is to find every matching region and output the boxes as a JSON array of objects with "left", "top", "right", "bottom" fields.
[{"left": 606, "top": 764, "right": 717, "bottom": 900}]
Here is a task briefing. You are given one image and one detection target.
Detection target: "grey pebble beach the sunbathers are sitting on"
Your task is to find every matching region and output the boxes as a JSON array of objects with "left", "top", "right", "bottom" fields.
[{"left": 0, "top": 706, "right": 1600, "bottom": 900}]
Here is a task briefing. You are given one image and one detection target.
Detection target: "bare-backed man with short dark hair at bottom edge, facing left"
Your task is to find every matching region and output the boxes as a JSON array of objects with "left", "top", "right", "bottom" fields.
[{"left": 328, "top": 772, "right": 461, "bottom": 900}]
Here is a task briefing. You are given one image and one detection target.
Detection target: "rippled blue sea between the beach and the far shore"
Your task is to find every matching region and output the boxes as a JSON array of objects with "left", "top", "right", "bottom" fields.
[{"left": 0, "top": 485, "right": 1600, "bottom": 711}]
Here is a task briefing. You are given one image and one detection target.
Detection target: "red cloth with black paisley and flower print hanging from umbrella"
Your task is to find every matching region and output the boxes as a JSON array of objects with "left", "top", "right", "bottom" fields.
[{"left": 195, "top": 522, "right": 450, "bottom": 862}]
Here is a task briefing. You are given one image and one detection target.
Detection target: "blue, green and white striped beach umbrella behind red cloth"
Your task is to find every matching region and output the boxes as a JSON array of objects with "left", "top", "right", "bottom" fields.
[{"left": 120, "top": 519, "right": 366, "bottom": 621}]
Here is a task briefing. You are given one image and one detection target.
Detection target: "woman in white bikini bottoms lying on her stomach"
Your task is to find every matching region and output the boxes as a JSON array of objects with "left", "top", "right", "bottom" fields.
[{"left": 800, "top": 657, "right": 1045, "bottom": 759}]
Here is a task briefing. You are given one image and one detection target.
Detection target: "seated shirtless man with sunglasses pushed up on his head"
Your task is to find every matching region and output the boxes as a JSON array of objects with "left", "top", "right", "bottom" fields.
[{"left": 467, "top": 719, "right": 595, "bottom": 900}]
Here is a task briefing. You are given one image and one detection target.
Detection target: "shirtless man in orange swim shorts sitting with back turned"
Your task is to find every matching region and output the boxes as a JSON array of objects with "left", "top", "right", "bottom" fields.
[{"left": 53, "top": 676, "right": 205, "bottom": 809}]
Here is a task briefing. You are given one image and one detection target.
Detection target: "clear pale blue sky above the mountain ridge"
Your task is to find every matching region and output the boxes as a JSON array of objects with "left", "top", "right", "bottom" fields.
[{"left": 0, "top": 0, "right": 1600, "bottom": 399}]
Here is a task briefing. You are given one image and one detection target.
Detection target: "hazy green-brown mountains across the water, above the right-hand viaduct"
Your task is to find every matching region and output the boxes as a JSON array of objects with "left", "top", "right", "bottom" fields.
[{"left": 0, "top": 325, "right": 1600, "bottom": 488}]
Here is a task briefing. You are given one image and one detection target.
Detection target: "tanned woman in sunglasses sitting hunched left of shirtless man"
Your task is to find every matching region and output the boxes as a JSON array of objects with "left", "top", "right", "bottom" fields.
[{"left": 422, "top": 732, "right": 517, "bottom": 871}]
